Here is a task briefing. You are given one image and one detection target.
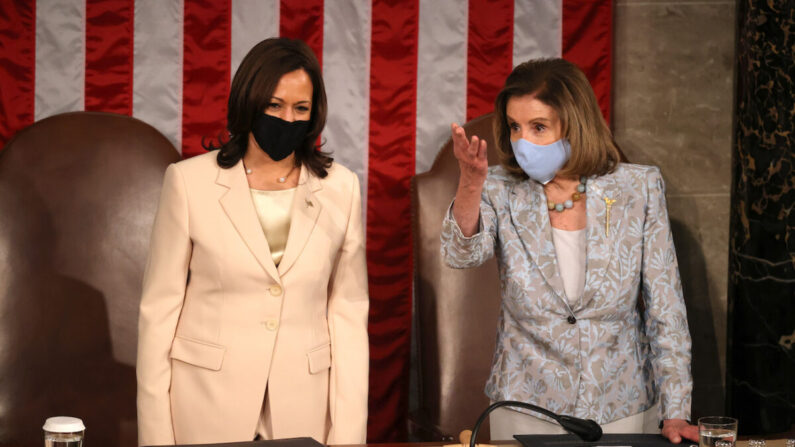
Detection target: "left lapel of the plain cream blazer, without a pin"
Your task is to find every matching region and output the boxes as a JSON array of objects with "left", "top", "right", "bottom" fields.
[{"left": 216, "top": 162, "right": 279, "bottom": 281}]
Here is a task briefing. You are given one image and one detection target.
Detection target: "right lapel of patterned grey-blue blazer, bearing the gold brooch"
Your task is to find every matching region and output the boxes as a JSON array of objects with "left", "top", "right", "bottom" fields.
[{"left": 579, "top": 174, "right": 625, "bottom": 307}]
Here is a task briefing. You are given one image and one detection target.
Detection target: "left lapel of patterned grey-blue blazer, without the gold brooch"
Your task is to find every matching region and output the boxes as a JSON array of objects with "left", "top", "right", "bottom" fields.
[{"left": 510, "top": 181, "right": 568, "bottom": 306}]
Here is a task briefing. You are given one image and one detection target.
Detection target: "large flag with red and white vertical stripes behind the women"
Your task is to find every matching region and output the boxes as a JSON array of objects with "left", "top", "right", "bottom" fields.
[{"left": 0, "top": 0, "right": 612, "bottom": 440}]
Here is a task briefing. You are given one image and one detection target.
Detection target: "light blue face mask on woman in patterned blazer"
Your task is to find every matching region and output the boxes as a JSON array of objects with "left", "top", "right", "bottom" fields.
[{"left": 511, "top": 138, "right": 571, "bottom": 185}]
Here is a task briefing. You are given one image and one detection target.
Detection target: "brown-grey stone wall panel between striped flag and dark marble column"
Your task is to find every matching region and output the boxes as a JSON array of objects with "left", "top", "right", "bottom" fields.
[{"left": 613, "top": 0, "right": 737, "bottom": 419}]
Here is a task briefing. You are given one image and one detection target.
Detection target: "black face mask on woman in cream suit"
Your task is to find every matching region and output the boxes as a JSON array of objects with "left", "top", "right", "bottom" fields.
[{"left": 251, "top": 113, "right": 309, "bottom": 161}]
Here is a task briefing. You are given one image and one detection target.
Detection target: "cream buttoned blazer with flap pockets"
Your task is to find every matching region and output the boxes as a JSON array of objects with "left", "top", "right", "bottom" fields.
[{"left": 137, "top": 152, "right": 369, "bottom": 445}]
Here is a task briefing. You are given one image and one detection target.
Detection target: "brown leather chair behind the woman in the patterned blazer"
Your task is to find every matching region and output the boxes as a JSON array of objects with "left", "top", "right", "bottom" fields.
[{"left": 412, "top": 114, "right": 500, "bottom": 440}]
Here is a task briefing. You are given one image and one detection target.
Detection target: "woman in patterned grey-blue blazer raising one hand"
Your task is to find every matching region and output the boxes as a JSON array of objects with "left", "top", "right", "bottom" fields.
[{"left": 442, "top": 59, "right": 698, "bottom": 443}]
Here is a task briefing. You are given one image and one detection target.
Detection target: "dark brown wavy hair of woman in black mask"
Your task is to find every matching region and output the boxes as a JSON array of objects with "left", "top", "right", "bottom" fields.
[{"left": 203, "top": 38, "right": 333, "bottom": 178}]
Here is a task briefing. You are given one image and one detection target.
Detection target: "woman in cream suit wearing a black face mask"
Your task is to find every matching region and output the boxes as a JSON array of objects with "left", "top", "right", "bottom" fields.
[{"left": 137, "top": 39, "right": 369, "bottom": 445}]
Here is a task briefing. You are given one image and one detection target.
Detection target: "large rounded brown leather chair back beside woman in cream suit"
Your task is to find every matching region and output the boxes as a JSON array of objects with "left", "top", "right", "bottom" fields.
[{"left": 0, "top": 112, "right": 179, "bottom": 447}]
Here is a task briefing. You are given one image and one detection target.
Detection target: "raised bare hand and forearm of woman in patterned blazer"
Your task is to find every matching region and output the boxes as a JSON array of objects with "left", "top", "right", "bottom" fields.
[{"left": 450, "top": 123, "right": 489, "bottom": 237}]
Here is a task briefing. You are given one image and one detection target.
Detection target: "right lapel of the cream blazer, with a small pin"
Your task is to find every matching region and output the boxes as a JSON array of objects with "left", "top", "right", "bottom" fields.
[{"left": 278, "top": 166, "right": 322, "bottom": 275}]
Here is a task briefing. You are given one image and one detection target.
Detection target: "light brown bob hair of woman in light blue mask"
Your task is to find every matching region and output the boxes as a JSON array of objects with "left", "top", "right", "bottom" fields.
[{"left": 494, "top": 59, "right": 621, "bottom": 178}]
